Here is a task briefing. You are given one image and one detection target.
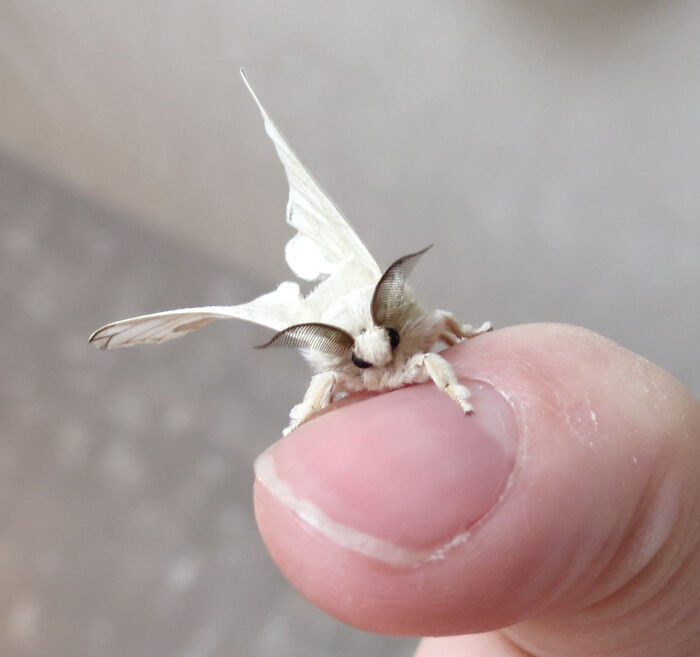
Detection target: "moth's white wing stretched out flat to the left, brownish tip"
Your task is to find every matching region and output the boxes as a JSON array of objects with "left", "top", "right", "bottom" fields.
[{"left": 90, "top": 282, "right": 302, "bottom": 349}]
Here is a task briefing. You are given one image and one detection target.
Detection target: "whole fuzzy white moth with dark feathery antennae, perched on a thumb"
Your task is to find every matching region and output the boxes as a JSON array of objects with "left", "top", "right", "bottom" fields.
[{"left": 90, "top": 70, "right": 491, "bottom": 435}]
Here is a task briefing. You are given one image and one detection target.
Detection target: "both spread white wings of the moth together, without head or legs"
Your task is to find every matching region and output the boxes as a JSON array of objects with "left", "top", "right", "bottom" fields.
[{"left": 90, "top": 69, "right": 381, "bottom": 349}]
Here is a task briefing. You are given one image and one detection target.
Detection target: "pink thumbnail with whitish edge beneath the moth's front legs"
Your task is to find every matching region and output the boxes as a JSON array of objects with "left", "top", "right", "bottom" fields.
[{"left": 256, "top": 381, "right": 518, "bottom": 566}]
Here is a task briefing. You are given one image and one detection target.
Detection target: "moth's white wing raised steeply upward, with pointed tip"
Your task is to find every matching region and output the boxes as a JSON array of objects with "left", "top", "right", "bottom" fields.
[{"left": 241, "top": 69, "right": 381, "bottom": 289}]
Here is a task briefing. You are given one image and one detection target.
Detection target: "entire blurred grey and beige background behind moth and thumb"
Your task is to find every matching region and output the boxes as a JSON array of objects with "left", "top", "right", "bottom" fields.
[{"left": 0, "top": 0, "right": 700, "bottom": 657}]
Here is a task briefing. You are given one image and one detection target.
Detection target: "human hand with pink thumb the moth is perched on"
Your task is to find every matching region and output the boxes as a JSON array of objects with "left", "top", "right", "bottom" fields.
[{"left": 255, "top": 324, "right": 700, "bottom": 657}]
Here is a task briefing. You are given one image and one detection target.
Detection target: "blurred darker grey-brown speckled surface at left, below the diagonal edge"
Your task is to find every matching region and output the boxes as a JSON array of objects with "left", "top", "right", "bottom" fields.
[{"left": 0, "top": 158, "right": 408, "bottom": 657}]
